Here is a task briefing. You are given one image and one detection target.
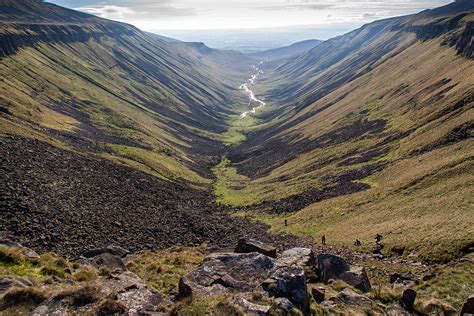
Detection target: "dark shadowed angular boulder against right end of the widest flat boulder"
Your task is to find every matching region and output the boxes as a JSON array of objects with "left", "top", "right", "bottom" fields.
[{"left": 262, "top": 266, "right": 307, "bottom": 309}]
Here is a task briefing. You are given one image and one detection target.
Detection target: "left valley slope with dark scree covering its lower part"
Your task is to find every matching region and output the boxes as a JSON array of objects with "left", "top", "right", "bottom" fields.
[{"left": 0, "top": 0, "right": 292, "bottom": 255}]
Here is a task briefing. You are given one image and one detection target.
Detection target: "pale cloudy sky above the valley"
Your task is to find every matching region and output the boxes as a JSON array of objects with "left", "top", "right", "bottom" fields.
[{"left": 47, "top": 0, "right": 452, "bottom": 33}]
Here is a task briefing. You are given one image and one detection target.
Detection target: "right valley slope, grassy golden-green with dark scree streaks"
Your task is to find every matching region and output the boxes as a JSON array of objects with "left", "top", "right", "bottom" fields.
[{"left": 218, "top": 1, "right": 474, "bottom": 260}]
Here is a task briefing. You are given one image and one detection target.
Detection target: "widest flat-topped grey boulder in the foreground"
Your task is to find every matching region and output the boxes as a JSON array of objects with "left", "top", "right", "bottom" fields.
[{"left": 179, "top": 252, "right": 276, "bottom": 297}]
